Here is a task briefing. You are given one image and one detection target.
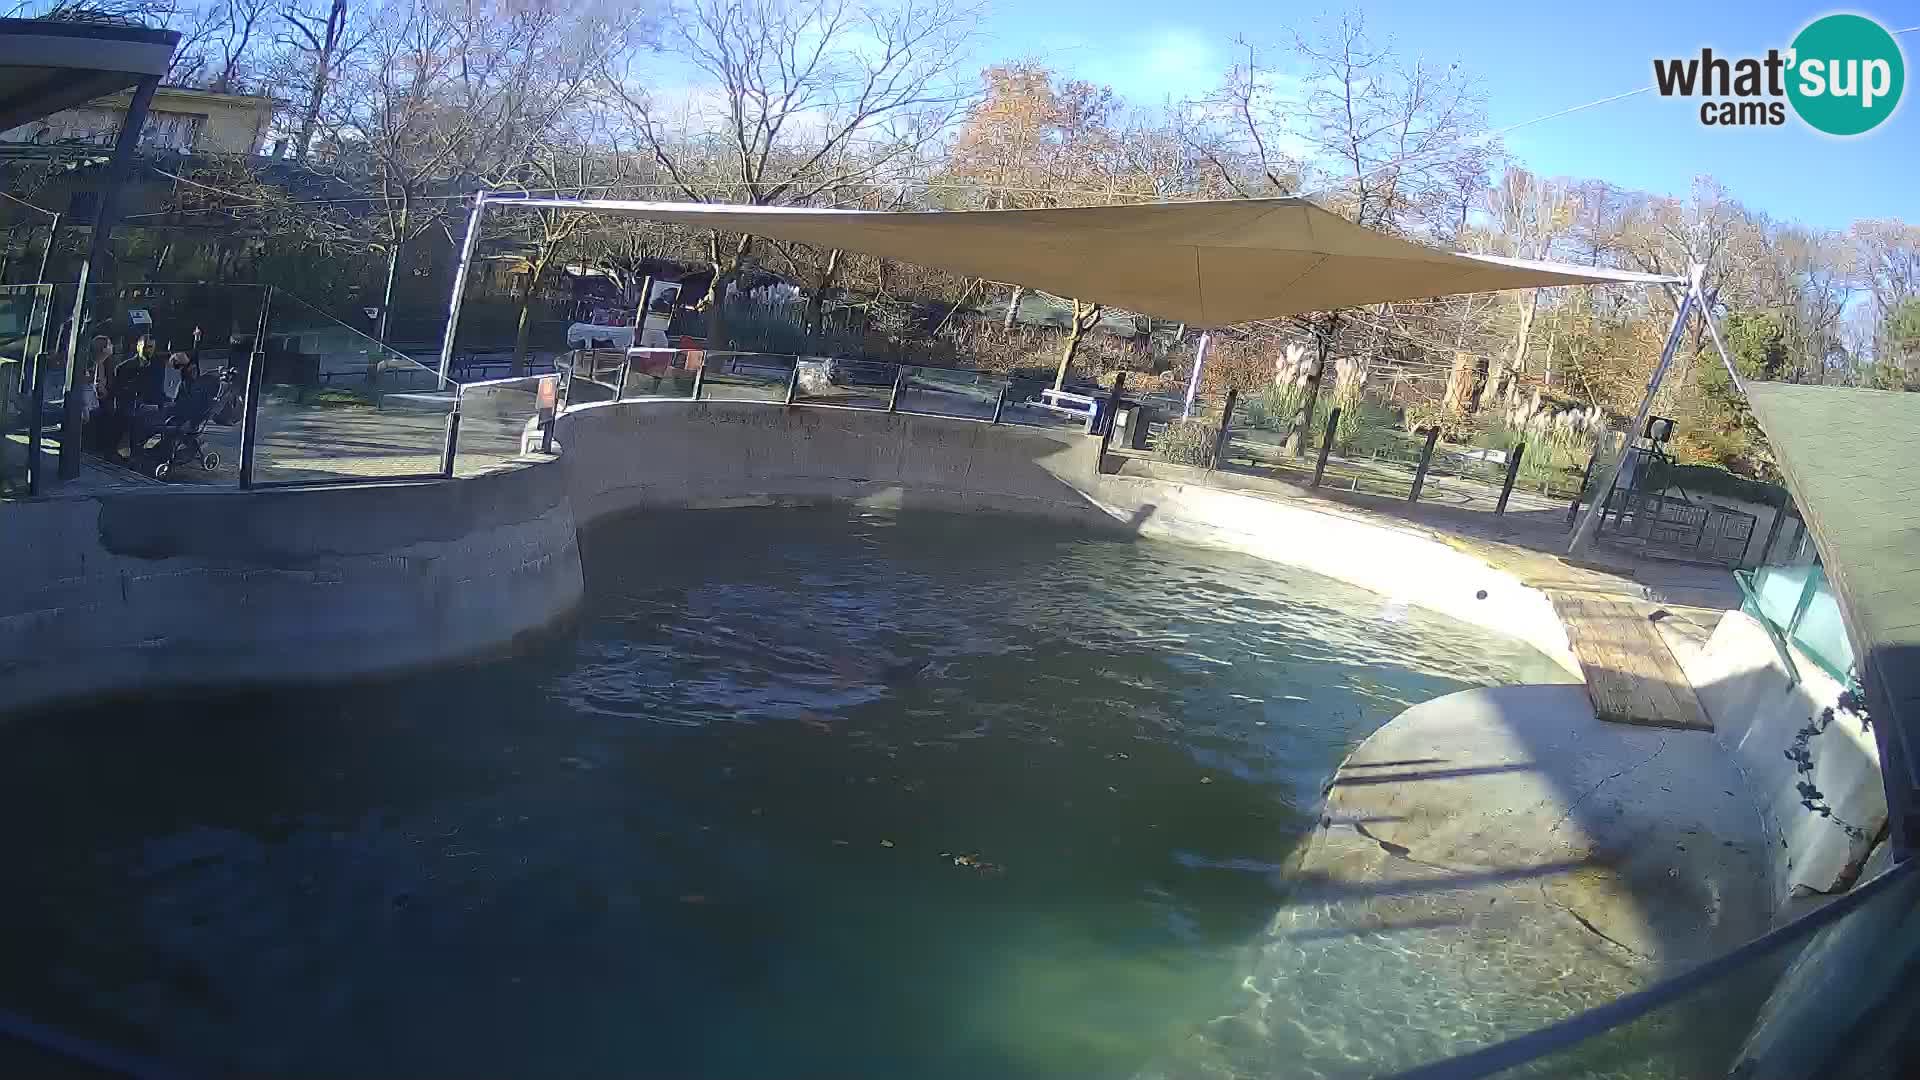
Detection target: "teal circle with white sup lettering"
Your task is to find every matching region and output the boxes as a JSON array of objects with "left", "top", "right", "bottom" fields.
[{"left": 1788, "top": 15, "right": 1907, "bottom": 135}]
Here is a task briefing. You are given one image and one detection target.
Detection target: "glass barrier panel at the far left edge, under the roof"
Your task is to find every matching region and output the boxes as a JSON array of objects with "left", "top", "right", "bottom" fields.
[{"left": 0, "top": 284, "right": 53, "bottom": 498}]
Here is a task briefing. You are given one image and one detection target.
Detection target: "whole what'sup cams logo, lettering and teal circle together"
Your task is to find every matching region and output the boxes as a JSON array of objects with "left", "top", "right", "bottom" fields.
[{"left": 1653, "top": 15, "right": 1907, "bottom": 136}]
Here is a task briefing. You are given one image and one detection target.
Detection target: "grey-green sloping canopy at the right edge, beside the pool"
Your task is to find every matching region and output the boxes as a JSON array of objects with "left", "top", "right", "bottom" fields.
[{"left": 1745, "top": 382, "right": 1920, "bottom": 826}]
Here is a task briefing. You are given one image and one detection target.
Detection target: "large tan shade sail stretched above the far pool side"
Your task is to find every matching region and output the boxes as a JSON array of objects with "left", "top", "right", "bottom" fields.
[{"left": 490, "top": 196, "right": 1686, "bottom": 327}]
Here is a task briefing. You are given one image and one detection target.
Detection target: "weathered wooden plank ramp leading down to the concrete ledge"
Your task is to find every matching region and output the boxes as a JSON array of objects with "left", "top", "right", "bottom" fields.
[{"left": 1548, "top": 592, "right": 1713, "bottom": 730}]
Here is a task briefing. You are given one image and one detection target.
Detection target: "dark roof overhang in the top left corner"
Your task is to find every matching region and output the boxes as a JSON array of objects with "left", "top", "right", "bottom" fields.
[{"left": 0, "top": 19, "right": 180, "bottom": 131}]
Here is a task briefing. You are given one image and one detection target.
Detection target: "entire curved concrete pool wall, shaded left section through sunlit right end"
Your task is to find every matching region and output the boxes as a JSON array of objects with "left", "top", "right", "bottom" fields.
[{"left": 0, "top": 402, "right": 1620, "bottom": 711}]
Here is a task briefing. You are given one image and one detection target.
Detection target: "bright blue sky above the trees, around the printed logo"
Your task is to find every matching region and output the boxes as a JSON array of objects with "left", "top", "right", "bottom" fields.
[{"left": 985, "top": 0, "right": 1920, "bottom": 227}]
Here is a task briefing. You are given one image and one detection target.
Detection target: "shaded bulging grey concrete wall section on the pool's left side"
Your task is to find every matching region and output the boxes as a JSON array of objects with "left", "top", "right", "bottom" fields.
[{"left": 0, "top": 461, "right": 582, "bottom": 711}]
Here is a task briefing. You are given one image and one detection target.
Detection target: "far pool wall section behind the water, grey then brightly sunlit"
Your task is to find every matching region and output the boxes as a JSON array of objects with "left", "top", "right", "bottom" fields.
[{"left": 557, "top": 402, "right": 1580, "bottom": 676}]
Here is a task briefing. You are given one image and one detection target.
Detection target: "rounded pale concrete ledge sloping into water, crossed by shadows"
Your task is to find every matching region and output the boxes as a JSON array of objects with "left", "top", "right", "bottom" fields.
[{"left": 1190, "top": 684, "right": 1768, "bottom": 1076}]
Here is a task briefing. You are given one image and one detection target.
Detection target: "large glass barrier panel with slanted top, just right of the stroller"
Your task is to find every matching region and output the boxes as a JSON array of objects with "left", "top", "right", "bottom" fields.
[{"left": 253, "top": 292, "right": 455, "bottom": 484}]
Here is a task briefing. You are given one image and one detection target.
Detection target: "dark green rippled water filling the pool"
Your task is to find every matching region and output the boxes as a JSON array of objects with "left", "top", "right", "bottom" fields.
[{"left": 0, "top": 509, "right": 1563, "bottom": 1078}]
